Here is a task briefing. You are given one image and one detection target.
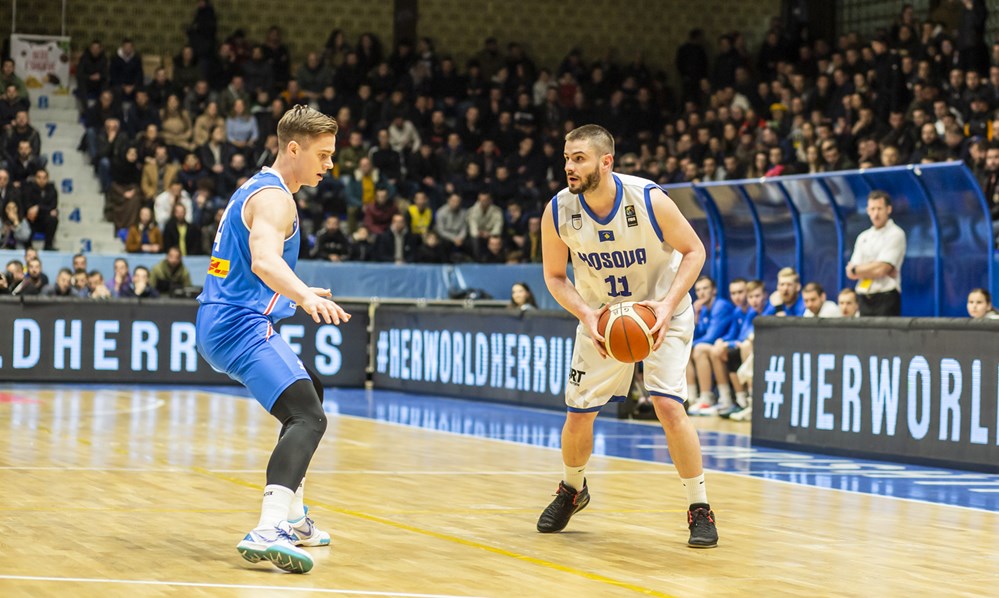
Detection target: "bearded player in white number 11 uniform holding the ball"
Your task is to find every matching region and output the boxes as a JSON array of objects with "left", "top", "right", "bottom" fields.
[{"left": 538, "top": 125, "right": 718, "bottom": 548}]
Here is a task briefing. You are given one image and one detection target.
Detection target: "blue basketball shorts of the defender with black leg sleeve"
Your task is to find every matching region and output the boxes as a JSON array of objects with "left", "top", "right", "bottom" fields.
[{"left": 195, "top": 303, "right": 311, "bottom": 413}]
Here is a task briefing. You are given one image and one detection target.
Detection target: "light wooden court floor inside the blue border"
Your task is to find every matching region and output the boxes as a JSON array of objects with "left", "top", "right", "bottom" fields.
[{"left": 0, "top": 385, "right": 999, "bottom": 598}]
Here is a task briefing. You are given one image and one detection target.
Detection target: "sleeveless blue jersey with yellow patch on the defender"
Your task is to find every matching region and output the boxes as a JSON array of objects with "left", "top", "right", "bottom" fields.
[{"left": 198, "top": 168, "right": 301, "bottom": 322}]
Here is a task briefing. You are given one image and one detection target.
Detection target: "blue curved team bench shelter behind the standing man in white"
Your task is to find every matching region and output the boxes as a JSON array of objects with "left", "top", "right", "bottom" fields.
[{"left": 664, "top": 162, "right": 993, "bottom": 316}]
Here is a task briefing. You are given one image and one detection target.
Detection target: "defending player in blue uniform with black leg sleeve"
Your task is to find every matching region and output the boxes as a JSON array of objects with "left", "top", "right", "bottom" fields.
[{"left": 197, "top": 106, "right": 350, "bottom": 573}]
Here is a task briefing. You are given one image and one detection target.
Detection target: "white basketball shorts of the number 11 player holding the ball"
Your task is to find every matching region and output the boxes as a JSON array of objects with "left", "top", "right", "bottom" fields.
[{"left": 565, "top": 306, "right": 694, "bottom": 413}]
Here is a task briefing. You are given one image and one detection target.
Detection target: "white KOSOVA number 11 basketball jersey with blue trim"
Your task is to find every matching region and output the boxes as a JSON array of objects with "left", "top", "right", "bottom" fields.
[{"left": 552, "top": 173, "right": 690, "bottom": 314}]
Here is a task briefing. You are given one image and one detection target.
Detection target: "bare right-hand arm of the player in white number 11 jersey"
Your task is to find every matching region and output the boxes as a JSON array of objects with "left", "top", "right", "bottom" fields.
[{"left": 642, "top": 189, "right": 704, "bottom": 351}]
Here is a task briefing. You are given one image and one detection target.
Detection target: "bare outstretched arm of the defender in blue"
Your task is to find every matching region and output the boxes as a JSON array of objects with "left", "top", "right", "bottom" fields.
[{"left": 245, "top": 189, "right": 350, "bottom": 324}]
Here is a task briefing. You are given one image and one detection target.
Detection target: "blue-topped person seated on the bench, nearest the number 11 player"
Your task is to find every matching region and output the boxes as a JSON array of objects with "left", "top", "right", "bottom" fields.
[{"left": 687, "top": 276, "right": 744, "bottom": 415}]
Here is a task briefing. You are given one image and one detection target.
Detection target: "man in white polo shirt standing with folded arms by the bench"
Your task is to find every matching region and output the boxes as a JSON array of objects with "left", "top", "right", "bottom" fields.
[{"left": 846, "top": 190, "right": 906, "bottom": 316}]
